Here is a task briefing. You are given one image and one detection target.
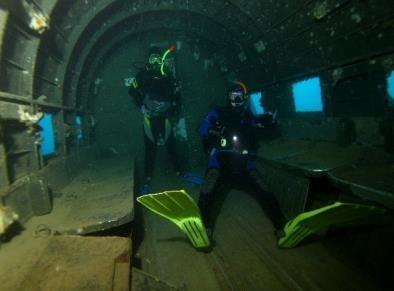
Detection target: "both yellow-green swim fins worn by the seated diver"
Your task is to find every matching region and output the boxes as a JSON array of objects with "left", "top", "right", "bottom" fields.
[{"left": 137, "top": 190, "right": 386, "bottom": 249}]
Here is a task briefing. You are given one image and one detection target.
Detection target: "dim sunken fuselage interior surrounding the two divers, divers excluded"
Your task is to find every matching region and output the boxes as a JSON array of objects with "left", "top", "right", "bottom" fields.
[{"left": 0, "top": 0, "right": 394, "bottom": 290}]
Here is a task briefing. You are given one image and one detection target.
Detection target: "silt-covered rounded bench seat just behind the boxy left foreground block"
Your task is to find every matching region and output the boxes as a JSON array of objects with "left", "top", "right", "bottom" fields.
[{"left": 26, "top": 159, "right": 134, "bottom": 234}]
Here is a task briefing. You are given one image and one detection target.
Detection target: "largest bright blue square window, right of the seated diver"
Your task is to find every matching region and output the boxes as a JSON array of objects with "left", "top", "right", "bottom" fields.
[{"left": 293, "top": 77, "right": 323, "bottom": 112}]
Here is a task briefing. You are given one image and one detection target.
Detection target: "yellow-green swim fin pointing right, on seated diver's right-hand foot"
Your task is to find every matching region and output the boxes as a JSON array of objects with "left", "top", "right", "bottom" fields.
[{"left": 278, "top": 202, "right": 385, "bottom": 248}]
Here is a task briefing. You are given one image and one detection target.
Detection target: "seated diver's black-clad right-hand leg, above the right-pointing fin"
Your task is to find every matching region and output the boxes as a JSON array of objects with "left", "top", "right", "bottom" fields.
[{"left": 248, "top": 169, "right": 286, "bottom": 230}]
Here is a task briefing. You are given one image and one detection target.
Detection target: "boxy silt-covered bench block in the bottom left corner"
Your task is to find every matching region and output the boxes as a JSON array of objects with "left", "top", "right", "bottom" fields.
[{"left": 0, "top": 236, "right": 131, "bottom": 290}]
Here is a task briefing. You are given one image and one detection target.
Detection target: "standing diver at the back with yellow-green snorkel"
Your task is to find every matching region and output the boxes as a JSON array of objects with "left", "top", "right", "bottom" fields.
[{"left": 129, "top": 47, "right": 185, "bottom": 194}]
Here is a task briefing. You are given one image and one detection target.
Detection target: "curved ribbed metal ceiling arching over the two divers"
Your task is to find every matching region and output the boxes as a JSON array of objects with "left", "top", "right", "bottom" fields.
[{"left": 2, "top": 0, "right": 394, "bottom": 114}]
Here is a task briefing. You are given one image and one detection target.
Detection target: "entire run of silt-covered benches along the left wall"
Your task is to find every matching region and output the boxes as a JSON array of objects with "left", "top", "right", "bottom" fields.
[{"left": 0, "top": 159, "right": 134, "bottom": 291}]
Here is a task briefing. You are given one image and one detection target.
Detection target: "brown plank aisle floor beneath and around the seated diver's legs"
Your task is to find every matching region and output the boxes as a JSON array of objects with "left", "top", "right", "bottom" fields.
[{"left": 136, "top": 174, "right": 376, "bottom": 290}]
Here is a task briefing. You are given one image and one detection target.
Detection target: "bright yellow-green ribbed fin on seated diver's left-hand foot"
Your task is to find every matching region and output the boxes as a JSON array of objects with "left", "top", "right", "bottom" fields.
[{"left": 137, "top": 190, "right": 209, "bottom": 249}]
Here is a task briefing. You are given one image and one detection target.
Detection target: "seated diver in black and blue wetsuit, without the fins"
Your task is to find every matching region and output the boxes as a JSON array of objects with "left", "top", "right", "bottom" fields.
[{"left": 198, "top": 82, "right": 285, "bottom": 240}]
